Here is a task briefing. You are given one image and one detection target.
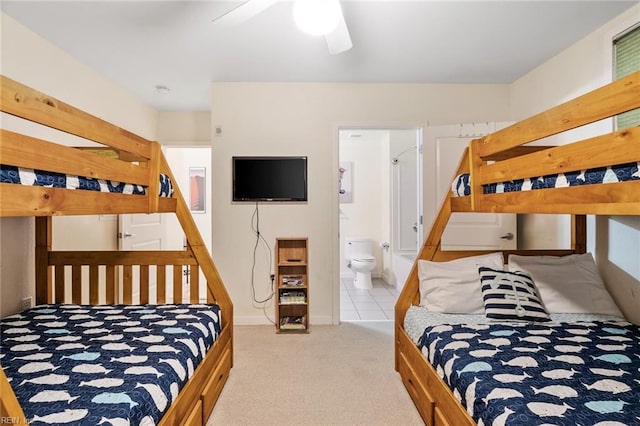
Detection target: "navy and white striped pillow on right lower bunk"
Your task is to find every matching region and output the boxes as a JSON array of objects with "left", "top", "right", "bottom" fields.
[{"left": 478, "top": 266, "right": 550, "bottom": 322}]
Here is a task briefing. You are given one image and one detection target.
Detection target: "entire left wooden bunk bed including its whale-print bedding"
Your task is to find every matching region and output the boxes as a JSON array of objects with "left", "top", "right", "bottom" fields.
[{"left": 0, "top": 76, "right": 233, "bottom": 425}]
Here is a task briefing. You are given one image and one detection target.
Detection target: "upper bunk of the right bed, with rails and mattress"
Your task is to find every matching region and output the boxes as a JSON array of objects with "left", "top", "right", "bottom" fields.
[{"left": 447, "top": 72, "right": 640, "bottom": 215}]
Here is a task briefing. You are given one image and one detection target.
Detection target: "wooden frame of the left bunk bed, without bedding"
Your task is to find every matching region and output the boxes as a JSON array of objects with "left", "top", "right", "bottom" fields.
[{"left": 0, "top": 76, "right": 233, "bottom": 425}]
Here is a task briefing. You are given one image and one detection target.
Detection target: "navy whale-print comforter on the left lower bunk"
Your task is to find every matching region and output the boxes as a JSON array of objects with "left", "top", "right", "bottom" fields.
[{"left": 0, "top": 305, "right": 220, "bottom": 425}]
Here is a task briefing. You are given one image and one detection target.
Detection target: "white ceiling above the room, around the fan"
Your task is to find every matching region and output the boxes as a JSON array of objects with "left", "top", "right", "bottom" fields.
[{"left": 1, "top": 0, "right": 639, "bottom": 111}]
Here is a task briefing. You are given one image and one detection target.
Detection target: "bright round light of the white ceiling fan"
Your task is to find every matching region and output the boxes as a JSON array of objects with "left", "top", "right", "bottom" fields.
[{"left": 293, "top": 0, "right": 342, "bottom": 36}]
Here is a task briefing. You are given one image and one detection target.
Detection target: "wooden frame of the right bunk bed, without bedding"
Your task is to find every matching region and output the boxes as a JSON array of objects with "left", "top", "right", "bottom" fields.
[{"left": 395, "top": 72, "right": 640, "bottom": 426}]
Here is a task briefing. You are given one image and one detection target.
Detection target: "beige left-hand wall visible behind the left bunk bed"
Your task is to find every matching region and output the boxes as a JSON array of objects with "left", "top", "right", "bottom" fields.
[{"left": 0, "top": 14, "right": 157, "bottom": 317}]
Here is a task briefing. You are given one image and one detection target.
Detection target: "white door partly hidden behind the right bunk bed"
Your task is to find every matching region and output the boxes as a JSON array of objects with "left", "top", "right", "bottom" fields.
[{"left": 424, "top": 123, "right": 517, "bottom": 250}]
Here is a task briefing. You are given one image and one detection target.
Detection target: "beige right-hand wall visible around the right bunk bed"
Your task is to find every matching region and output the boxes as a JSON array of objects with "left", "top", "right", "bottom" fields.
[{"left": 510, "top": 5, "right": 640, "bottom": 323}]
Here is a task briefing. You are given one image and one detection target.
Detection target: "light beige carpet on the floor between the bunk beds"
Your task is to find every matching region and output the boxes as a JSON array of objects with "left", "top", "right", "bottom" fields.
[{"left": 207, "top": 322, "right": 424, "bottom": 426}]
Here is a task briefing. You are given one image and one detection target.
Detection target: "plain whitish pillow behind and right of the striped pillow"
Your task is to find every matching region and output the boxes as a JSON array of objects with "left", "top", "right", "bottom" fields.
[{"left": 509, "top": 253, "right": 623, "bottom": 317}]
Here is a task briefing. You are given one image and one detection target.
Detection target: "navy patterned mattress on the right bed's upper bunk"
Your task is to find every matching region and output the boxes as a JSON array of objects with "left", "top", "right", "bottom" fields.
[{"left": 451, "top": 162, "right": 640, "bottom": 197}]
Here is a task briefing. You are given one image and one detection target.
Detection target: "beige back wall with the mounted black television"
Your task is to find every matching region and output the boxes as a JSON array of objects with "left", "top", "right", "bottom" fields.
[{"left": 212, "top": 83, "right": 509, "bottom": 324}]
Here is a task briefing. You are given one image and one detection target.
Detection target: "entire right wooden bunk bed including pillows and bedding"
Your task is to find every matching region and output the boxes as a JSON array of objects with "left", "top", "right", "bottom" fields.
[{"left": 395, "top": 72, "right": 640, "bottom": 425}]
